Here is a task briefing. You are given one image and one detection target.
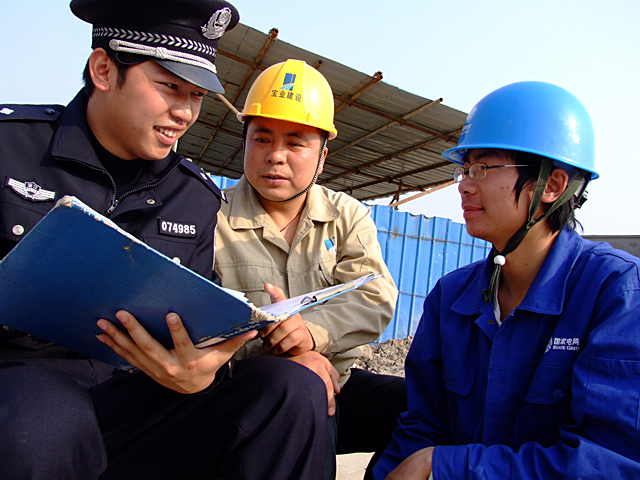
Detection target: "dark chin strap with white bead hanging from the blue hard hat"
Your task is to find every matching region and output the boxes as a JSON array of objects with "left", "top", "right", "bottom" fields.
[{"left": 482, "top": 161, "right": 591, "bottom": 303}]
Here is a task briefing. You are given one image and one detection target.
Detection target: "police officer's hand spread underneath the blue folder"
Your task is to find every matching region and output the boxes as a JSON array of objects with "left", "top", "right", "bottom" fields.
[{"left": 98, "top": 310, "right": 256, "bottom": 393}]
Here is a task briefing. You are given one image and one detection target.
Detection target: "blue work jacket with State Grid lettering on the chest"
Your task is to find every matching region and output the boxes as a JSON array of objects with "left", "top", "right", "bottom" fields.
[{"left": 374, "top": 230, "right": 640, "bottom": 480}]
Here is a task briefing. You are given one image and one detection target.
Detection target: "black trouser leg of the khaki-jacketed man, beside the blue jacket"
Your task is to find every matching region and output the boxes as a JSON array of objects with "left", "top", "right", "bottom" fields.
[{"left": 336, "top": 368, "right": 407, "bottom": 480}]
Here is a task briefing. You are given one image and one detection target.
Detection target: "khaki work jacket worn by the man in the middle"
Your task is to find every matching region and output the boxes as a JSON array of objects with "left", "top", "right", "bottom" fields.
[{"left": 215, "top": 176, "right": 398, "bottom": 385}]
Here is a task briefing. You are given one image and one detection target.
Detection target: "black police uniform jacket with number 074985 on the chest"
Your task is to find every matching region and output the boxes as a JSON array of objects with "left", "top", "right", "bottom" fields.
[{"left": 0, "top": 92, "right": 223, "bottom": 352}]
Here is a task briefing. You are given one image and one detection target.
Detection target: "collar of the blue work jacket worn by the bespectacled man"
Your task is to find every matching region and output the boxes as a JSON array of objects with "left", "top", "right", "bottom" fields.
[{"left": 452, "top": 228, "right": 583, "bottom": 315}]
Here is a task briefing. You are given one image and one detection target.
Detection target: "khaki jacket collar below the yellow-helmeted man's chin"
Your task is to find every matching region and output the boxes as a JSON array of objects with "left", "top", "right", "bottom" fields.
[{"left": 229, "top": 175, "right": 340, "bottom": 230}]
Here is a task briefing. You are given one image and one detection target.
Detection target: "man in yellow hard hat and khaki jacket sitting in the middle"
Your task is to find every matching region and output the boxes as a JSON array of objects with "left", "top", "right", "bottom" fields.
[{"left": 215, "top": 60, "right": 406, "bottom": 476}]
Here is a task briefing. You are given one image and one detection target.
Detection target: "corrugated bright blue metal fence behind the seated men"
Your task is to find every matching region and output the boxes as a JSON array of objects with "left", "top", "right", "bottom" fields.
[{"left": 211, "top": 175, "right": 491, "bottom": 342}]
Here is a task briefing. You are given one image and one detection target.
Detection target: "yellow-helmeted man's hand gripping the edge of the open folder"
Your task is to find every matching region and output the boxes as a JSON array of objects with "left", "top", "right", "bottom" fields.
[{"left": 258, "top": 283, "right": 316, "bottom": 355}]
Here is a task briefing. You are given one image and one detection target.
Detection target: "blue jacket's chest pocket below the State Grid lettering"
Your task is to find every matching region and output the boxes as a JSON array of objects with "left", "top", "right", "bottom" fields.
[{"left": 513, "top": 365, "right": 573, "bottom": 447}]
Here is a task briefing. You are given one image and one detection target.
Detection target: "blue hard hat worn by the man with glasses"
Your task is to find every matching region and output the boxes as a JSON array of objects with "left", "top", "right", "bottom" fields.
[{"left": 442, "top": 82, "right": 599, "bottom": 179}]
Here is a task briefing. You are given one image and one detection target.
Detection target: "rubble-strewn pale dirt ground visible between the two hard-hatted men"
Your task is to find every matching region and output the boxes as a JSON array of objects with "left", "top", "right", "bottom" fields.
[{"left": 336, "top": 337, "right": 413, "bottom": 480}]
